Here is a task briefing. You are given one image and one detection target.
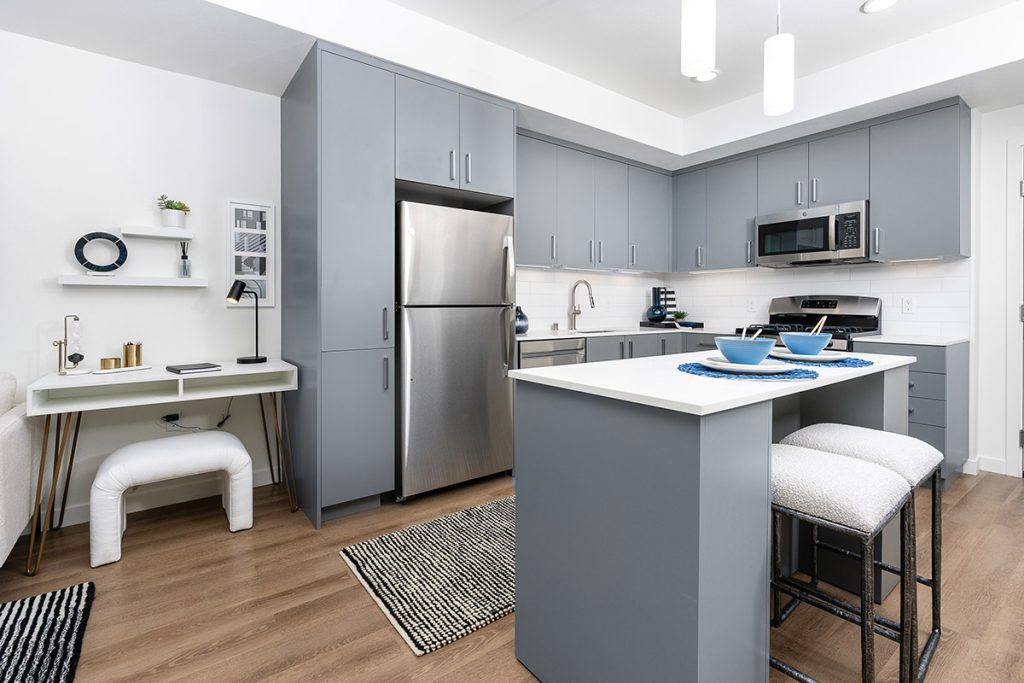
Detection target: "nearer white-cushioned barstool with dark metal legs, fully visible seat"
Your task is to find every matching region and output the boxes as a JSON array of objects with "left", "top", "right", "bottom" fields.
[{"left": 771, "top": 443, "right": 915, "bottom": 682}]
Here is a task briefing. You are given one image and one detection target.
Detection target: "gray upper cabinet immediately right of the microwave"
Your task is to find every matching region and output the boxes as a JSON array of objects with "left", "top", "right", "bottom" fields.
[{"left": 870, "top": 102, "right": 971, "bottom": 261}]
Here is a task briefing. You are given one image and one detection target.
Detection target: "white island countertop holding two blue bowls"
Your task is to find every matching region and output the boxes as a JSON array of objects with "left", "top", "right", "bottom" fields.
[{"left": 509, "top": 351, "right": 916, "bottom": 415}]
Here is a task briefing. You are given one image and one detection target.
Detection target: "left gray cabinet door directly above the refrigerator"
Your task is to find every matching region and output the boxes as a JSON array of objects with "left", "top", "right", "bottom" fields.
[{"left": 394, "top": 76, "right": 459, "bottom": 187}]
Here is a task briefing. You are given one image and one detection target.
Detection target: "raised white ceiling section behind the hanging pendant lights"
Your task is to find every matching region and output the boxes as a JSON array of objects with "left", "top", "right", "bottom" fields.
[{"left": 392, "top": 0, "right": 1014, "bottom": 117}]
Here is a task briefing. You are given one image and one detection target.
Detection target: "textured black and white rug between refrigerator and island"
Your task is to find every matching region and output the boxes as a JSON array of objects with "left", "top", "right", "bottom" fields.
[{"left": 341, "top": 497, "right": 515, "bottom": 655}]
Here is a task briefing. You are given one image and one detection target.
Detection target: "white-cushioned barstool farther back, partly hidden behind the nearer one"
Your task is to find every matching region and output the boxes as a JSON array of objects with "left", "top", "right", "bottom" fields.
[{"left": 782, "top": 423, "right": 942, "bottom": 678}]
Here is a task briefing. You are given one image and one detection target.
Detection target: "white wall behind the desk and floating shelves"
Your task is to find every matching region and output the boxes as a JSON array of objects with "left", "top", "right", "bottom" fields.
[{"left": 0, "top": 32, "right": 281, "bottom": 522}]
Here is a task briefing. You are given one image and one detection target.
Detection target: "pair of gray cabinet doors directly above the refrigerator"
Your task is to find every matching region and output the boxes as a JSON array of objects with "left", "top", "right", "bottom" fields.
[{"left": 394, "top": 75, "right": 515, "bottom": 197}]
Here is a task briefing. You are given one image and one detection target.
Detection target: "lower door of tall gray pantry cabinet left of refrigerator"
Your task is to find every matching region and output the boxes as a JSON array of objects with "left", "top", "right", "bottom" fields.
[{"left": 321, "top": 349, "right": 395, "bottom": 507}]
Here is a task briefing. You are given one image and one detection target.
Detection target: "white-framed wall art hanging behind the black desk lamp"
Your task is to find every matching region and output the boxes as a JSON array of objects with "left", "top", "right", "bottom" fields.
[{"left": 224, "top": 197, "right": 278, "bottom": 307}]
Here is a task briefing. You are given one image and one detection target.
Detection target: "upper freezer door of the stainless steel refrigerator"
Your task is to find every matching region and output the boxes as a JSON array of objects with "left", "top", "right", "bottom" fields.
[{"left": 398, "top": 202, "right": 515, "bottom": 306}]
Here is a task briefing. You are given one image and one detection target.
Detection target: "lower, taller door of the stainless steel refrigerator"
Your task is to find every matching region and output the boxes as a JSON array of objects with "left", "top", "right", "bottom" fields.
[{"left": 398, "top": 307, "right": 515, "bottom": 497}]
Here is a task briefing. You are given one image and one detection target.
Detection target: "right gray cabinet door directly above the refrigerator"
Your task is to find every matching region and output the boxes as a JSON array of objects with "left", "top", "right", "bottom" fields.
[{"left": 459, "top": 94, "right": 515, "bottom": 197}]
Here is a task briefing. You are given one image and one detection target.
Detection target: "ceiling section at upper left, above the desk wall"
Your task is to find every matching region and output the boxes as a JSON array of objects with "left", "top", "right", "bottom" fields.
[{"left": 0, "top": 0, "right": 313, "bottom": 95}]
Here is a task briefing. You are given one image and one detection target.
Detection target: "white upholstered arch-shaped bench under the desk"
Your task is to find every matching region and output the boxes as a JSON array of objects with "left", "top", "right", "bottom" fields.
[{"left": 89, "top": 431, "right": 253, "bottom": 567}]
